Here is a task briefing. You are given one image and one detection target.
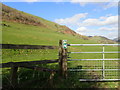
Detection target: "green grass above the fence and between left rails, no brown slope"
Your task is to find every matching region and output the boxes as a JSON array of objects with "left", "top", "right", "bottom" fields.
[{"left": 2, "top": 21, "right": 100, "bottom": 63}]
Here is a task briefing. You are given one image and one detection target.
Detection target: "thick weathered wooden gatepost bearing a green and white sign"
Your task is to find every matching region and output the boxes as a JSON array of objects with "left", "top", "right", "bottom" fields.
[{"left": 59, "top": 40, "right": 67, "bottom": 78}]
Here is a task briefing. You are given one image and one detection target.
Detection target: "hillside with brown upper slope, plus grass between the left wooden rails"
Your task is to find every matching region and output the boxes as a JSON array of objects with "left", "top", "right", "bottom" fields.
[{"left": 2, "top": 5, "right": 102, "bottom": 62}]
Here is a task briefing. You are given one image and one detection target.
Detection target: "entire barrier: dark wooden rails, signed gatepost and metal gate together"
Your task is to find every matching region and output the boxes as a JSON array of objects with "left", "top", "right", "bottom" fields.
[{"left": 1, "top": 40, "right": 120, "bottom": 87}]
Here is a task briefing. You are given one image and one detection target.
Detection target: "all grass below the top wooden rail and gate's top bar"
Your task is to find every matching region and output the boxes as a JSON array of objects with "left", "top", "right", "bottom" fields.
[{"left": 3, "top": 47, "right": 119, "bottom": 88}]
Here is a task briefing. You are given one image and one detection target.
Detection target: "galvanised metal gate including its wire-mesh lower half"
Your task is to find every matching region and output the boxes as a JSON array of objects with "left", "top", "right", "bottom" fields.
[{"left": 65, "top": 41, "right": 120, "bottom": 81}]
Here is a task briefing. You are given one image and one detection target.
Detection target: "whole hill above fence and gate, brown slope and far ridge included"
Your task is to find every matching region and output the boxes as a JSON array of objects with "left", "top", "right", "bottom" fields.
[{"left": 2, "top": 4, "right": 114, "bottom": 45}]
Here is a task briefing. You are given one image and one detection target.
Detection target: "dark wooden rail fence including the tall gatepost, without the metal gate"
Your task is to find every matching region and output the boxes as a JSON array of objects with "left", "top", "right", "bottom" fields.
[{"left": 0, "top": 40, "right": 67, "bottom": 88}]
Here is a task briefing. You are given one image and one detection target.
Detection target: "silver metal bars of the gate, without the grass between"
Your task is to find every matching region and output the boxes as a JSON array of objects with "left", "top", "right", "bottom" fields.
[{"left": 67, "top": 40, "right": 120, "bottom": 81}]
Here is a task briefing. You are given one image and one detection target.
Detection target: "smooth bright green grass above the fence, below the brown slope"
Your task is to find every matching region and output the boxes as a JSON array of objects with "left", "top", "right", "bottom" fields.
[{"left": 2, "top": 22, "right": 97, "bottom": 46}]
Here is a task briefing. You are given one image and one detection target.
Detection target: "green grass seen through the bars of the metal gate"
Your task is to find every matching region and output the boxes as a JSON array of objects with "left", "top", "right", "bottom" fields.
[{"left": 68, "top": 46, "right": 120, "bottom": 82}]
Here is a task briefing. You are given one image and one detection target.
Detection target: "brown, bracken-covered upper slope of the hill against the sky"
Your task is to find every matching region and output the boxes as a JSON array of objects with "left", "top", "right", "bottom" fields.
[{"left": 2, "top": 4, "right": 84, "bottom": 35}]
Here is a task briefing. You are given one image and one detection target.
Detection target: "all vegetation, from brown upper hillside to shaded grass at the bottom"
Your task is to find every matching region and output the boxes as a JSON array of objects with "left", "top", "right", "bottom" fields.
[{"left": 2, "top": 5, "right": 119, "bottom": 88}]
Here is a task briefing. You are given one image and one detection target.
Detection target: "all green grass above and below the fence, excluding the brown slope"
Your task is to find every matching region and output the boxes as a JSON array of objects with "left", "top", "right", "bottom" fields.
[{"left": 2, "top": 21, "right": 119, "bottom": 88}]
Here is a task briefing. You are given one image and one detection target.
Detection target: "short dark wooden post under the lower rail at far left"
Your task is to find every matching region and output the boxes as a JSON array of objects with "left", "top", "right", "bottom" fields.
[{"left": 10, "top": 66, "right": 18, "bottom": 88}]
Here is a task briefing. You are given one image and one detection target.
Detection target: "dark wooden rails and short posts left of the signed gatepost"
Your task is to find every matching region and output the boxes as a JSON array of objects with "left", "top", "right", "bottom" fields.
[{"left": 0, "top": 44, "right": 58, "bottom": 88}]
